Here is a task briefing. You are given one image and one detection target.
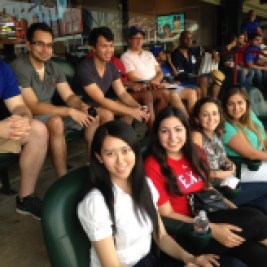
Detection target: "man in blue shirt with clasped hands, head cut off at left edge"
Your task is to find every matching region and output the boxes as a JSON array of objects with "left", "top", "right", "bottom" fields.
[{"left": 0, "top": 60, "right": 48, "bottom": 219}]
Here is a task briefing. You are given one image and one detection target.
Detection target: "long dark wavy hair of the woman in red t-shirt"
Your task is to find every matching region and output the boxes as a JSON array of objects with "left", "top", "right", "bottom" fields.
[{"left": 148, "top": 106, "right": 209, "bottom": 195}]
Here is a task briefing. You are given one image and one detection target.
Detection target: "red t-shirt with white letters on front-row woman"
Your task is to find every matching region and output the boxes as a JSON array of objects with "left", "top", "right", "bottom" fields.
[{"left": 145, "top": 156, "right": 204, "bottom": 216}]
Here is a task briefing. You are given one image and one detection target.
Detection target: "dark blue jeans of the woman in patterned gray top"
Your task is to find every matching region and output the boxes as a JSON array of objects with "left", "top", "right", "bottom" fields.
[{"left": 230, "top": 182, "right": 267, "bottom": 214}]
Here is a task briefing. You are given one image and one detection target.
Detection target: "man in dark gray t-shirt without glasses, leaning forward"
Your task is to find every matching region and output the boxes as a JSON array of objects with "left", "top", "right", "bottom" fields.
[{"left": 76, "top": 27, "right": 149, "bottom": 126}]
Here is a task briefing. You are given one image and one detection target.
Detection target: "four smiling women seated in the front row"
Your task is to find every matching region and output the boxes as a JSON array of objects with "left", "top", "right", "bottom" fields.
[{"left": 78, "top": 86, "right": 267, "bottom": 267}]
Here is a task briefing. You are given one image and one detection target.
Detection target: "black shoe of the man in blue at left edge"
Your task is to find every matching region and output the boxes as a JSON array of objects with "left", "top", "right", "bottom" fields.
[{"left": 16, "top": 194, "right": 42, "bottom": 220}]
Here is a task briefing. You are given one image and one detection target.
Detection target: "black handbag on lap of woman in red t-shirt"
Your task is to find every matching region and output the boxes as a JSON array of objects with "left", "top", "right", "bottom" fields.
[{"left": 187, "top": 189, "right": 228, "bottom": 216}]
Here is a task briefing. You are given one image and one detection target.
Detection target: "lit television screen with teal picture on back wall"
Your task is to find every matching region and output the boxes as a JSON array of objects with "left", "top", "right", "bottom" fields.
[{"left": 157, "top": 13, "right": 185, "bottom": 37}]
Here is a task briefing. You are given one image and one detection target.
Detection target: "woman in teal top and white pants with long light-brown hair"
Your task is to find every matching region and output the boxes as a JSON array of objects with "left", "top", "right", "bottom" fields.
[{"left": 222, "top": 87, "right": 267, "bottom": 182}]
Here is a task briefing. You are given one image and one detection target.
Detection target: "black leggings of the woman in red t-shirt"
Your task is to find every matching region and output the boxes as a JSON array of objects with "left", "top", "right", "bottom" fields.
[{"left": 192, "top": 207, "right": 267, "bottom": 267}]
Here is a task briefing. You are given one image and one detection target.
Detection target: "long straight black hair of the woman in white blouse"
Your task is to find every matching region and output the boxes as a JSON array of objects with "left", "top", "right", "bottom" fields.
[{"left": 81, "top": 120, "right": 159, "bottom": 235}]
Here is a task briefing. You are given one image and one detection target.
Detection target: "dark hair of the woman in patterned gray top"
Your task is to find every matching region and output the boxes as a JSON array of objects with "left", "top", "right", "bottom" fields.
[{"left": 189, "top": 97, "right": 225, "bottom": 137}]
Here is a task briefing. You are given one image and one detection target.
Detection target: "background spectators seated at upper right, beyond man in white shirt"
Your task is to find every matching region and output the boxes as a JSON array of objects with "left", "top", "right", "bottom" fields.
[{"left": 151, "top": 10, "right": 267, "bottom": 98}]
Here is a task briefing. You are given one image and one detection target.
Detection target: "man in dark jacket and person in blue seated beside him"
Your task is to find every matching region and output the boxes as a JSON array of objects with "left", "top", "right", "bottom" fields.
[{"left": 151, "top": 30, "right": 225, "bottom": 100}]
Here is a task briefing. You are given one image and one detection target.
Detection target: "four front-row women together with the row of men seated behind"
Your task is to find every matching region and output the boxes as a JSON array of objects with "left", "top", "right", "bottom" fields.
[{"left": 0, "top": 18, "right": 267, "bottom": 267}]
